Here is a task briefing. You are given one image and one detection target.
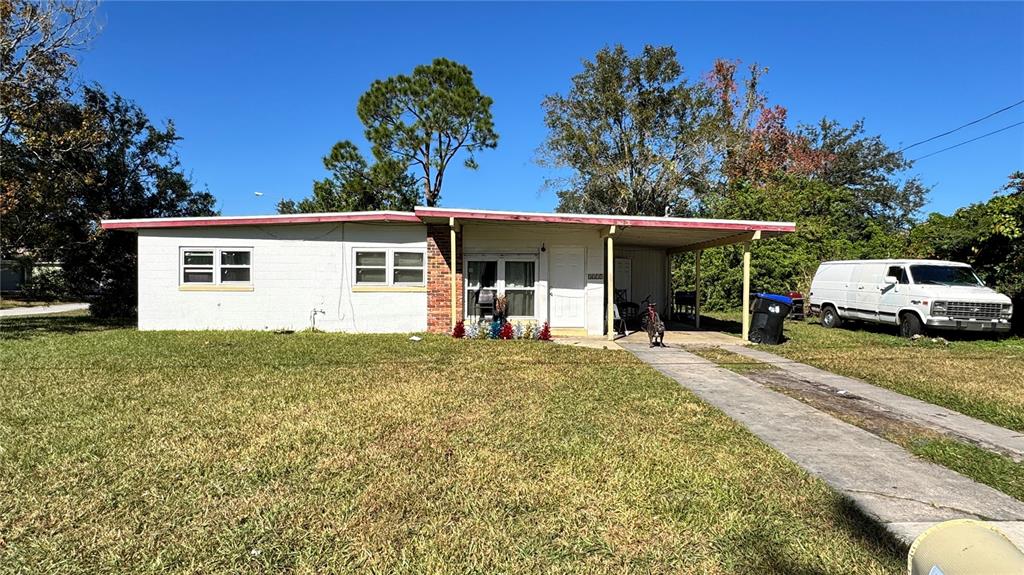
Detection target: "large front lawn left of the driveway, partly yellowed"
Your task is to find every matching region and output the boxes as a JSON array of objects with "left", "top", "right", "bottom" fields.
[{"left": 0, "top": 317, "right": 901, "bottom": 573}]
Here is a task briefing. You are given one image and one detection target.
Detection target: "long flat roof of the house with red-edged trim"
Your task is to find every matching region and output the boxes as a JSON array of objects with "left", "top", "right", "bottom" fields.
[{"left": 100, "top": 207, "right": 797, "bottom": 252}]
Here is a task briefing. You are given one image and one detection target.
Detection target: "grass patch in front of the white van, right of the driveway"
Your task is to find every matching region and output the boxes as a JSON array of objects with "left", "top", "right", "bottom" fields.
[{"left": 709, "top": 313, "right": 1024, "bottom": 432}]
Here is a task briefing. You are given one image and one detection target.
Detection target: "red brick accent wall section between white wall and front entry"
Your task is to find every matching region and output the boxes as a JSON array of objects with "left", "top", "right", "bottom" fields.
[{"left": 427, "top": 224, "right": 465, "bottom": 334}]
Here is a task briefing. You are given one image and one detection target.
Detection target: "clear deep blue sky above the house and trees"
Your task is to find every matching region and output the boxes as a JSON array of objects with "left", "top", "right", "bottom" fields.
[{"left": 79, "top": 2, "right": 1024, "bottom": 215}]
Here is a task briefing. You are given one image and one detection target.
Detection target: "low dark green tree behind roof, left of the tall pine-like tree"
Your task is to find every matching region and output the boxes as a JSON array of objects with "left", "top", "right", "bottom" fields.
[{"left": 278, "top": 140, "right": 419, "bottom": 214}]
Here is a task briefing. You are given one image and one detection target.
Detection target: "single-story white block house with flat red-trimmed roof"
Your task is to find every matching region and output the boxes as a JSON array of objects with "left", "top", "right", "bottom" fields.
[{"left": 102, "top": 208, "right": 795, "bottom": 336}]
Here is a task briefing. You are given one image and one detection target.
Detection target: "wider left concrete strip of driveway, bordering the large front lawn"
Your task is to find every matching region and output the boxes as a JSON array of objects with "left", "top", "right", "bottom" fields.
[{"left": 620, "top": 342, "right": 1024, "bottom": 548}]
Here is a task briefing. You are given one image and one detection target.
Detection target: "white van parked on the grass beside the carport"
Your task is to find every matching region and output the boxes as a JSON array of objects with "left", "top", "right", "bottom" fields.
[{"left": 809, "top": 260, "right": 1013, "bottom": 338}]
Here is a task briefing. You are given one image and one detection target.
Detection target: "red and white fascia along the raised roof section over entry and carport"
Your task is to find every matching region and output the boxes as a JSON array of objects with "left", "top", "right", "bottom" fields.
[{"left": 416, "top": 210, "right": 797, "bottom": 231}]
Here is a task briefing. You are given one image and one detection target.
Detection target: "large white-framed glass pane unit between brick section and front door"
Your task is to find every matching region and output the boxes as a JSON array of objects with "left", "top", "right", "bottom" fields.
[{"left": 465, "top": 256, "right": 537, "bottom": 319}]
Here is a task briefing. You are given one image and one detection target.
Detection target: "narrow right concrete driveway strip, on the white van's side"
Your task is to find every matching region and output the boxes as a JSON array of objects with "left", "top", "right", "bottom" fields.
[{"left": 721, "top": 346, "right": 1024, "bottom": 461}]
